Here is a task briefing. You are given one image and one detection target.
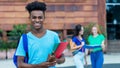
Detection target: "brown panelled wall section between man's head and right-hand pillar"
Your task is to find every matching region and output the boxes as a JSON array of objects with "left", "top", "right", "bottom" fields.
[{"left": 45, "top": 0, "right": 98, "bottom": 29}]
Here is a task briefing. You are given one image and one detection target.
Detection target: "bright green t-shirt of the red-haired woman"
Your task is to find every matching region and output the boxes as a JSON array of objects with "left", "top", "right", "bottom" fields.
[{"left": 88, "top": 34, "right": 105, "bottom": 52}]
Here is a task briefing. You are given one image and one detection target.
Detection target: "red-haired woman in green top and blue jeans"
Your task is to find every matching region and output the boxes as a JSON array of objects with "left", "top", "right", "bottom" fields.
[{"left": 88, "top": 24, "right": 105, "bottom": 68}]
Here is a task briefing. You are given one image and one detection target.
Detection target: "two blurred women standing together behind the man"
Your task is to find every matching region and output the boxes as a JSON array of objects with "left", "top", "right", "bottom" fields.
[{"left": 70, "top": 24, "right": 105, "bottom": 68}]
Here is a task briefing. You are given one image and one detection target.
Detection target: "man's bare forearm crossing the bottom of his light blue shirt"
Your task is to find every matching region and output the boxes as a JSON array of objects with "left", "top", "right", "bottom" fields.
[{"left": 17, "top": 56, "right": 56, "bottom": 68}]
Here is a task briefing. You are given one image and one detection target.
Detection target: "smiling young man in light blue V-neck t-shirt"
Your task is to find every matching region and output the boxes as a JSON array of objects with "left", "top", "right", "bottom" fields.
[{"left": 16, "top": 1, "right": 65, "bottom": 68}]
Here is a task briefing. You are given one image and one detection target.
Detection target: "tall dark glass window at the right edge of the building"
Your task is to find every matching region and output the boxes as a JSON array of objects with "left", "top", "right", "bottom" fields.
[{"left": 106, "top": 0, "right": 120, "bottom": 40}]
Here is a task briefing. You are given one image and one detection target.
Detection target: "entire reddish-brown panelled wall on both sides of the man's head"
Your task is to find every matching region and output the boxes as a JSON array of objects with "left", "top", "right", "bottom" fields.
[{"left": 0, "top": 0, "right": 105, "bottom": 30}]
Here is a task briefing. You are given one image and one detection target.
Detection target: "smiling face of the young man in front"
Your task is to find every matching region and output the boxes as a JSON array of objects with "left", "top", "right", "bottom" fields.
[{"left": 30, "top": 10, "right": 44, "bottom": 30}]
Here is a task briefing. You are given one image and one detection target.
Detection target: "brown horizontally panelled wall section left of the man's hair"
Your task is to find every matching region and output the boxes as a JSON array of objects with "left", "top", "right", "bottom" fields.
[{"left": 0, "top": 0, "right": 28, "bottom": 30}]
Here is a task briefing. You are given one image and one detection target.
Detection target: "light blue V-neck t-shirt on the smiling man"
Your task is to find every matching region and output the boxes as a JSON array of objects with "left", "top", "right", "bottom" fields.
[{"left": 16, "top": 30, "right": 60, "bottom": 64}]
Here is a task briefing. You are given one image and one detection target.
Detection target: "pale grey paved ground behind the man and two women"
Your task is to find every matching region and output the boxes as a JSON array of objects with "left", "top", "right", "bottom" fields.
[{"left": 0, "top": 54, "right": 120, "bottom": 68}]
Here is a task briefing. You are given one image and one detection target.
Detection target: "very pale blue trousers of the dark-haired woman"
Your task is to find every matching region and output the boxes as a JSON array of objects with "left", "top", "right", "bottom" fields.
[{"left": 73, "top": 52, "right": 85, "bottom": 68}]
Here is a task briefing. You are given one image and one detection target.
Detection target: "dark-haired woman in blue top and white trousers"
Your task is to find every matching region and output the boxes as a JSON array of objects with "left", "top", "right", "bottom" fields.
[{"left": 70, "top": 24, "right": 87, "bottom": 68}]
